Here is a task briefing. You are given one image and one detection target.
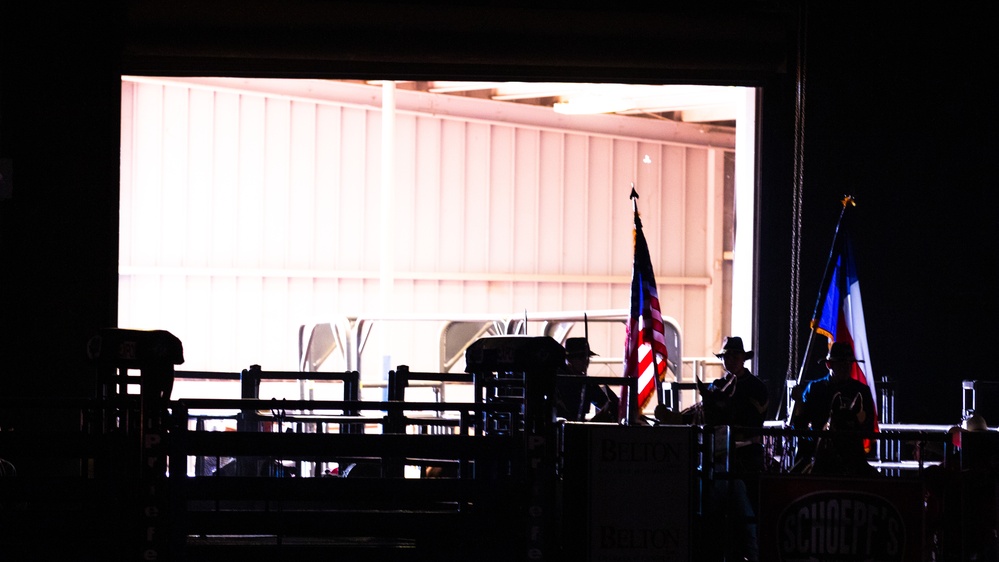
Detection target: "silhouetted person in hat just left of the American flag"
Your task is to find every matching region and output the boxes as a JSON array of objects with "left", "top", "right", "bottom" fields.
[{"left": 555, "top": 338, "right": 618, "bottom": 422}]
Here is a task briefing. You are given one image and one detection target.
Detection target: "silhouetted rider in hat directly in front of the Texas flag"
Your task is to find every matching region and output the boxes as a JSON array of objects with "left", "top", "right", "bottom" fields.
[{"left": 790, "top": 342, "right": 875, "bottom": 474}]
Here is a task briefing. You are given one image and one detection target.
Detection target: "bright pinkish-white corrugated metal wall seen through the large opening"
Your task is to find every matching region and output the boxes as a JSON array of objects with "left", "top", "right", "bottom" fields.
[{"left": 119, "top": 79, "right": 734, "bottom": 388}]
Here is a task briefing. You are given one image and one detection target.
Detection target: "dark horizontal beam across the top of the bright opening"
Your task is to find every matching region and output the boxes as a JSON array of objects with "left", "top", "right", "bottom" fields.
[{"left": 123, "top": 0, "right": 796, "bottom": 82}]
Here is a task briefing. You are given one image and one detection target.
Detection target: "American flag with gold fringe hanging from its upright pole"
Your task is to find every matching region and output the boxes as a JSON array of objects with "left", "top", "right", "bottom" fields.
[{"left": 619, "top": 188, "right": 668, "bottom": 419}]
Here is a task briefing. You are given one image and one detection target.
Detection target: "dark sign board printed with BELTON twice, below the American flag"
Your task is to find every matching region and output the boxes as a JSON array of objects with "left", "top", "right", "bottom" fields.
[{"left": 561, "top": 423, "right": 696, "bottom": 562}]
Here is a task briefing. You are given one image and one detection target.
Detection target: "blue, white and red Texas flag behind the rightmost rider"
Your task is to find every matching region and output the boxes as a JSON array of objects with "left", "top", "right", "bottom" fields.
[{"left": 812, "top": 232, "right": 878, "bottom": 431}]
